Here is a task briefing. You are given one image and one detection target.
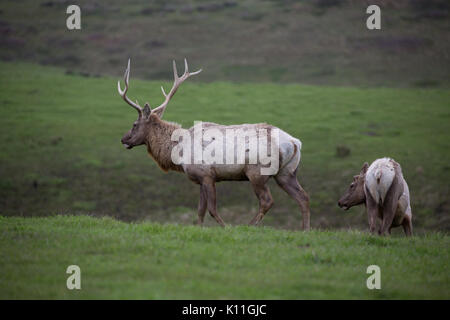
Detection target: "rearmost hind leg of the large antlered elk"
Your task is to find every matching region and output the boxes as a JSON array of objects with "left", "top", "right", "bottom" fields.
[{"left": 275, "top": 170, "right": 311, "bottom": 231}]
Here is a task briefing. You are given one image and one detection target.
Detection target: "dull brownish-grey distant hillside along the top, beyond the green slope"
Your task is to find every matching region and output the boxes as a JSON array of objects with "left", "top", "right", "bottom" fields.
[{"left": 0, "top": 0, "right": 450, "bottom": 87}]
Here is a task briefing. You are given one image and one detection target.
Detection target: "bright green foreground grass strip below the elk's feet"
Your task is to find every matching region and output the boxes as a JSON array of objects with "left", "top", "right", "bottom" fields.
[{"left": 0, "top": 216, "right": 450, "bottom": 299}]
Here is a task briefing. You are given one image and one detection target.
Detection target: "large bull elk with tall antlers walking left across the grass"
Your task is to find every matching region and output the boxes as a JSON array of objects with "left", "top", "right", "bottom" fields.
[{"left": 117, "top": 59, "right": 310, "bottom": 230}]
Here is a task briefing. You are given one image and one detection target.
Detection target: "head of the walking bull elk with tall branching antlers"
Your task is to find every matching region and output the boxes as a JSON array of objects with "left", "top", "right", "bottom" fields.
[{"left": 117, "top": 59, "right": 202, "bottom": 149}]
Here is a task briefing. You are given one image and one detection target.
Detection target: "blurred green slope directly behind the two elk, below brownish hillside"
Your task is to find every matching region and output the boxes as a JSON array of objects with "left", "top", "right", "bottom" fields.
[{"left": 0, "top": 62, "right": 450, "bottom": 232}]
